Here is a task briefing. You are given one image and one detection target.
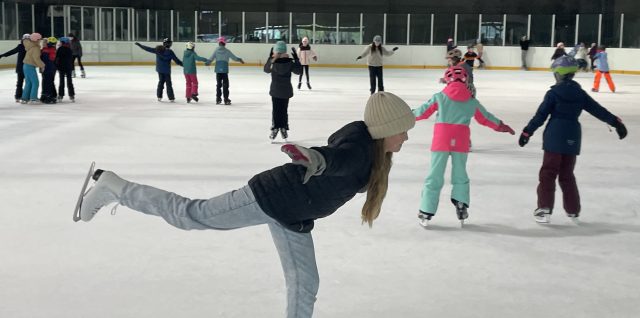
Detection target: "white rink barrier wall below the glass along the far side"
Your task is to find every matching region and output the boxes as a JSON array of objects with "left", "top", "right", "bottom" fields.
[{"left": 0, "top": 41, "right": 640, "bottom": 75}]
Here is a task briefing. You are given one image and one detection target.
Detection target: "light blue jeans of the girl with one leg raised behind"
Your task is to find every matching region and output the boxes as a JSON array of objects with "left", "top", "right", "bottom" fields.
[{"left": 120, "top": 182, "right": 320, "bottom": 318}]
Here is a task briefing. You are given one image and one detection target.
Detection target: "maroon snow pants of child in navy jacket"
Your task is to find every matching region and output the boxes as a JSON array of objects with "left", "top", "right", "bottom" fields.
[{"left": 538, "top": 151, "right": 580, "bottom": 214}]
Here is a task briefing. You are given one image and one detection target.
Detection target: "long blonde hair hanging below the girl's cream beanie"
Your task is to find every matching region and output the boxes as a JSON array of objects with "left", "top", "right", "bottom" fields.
[{"left": 362, "top": 138, "right": 393, "bottom": 227}]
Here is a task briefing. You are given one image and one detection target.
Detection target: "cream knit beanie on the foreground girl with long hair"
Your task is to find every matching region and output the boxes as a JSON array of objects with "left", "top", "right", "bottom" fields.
[{"left": 364, "top": 92, "right": 416, "bottom": 139}]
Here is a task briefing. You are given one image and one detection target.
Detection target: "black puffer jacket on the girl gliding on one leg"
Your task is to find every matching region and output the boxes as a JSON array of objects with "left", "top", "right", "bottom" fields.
[{"left": 249, "top": 121, "right": 373, "bottom": 232}]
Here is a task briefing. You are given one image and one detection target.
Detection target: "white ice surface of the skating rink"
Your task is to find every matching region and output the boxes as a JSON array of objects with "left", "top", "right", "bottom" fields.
[{"left": 0, "top": 66, "right": 640, "bottom": 318}]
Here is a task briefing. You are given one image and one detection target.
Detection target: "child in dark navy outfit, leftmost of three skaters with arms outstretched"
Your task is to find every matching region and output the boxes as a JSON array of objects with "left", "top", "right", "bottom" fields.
[{"left": 135, "top": 38, "right": 182, "bottom": 103}]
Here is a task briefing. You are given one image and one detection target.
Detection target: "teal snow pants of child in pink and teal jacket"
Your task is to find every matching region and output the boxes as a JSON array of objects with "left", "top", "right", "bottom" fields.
[{"left": 420, "top": 151, "right": 470, "bottom": 214}]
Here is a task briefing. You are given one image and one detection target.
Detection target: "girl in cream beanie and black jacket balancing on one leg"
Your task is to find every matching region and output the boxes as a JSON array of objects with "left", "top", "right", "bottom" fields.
[{"left": 74, "top": 90, "right": 415, "bottom": 318}]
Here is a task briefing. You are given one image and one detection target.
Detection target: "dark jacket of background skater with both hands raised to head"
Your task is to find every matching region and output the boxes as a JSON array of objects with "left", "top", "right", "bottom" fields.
[{"left": 264, "top": 57, "right": 302, "bottom": 99}]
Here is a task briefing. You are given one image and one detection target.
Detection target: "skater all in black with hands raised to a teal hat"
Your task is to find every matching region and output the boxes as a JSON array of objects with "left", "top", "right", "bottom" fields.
[{"left": 264, "top": 41, "right": 302, "bottom": 141}]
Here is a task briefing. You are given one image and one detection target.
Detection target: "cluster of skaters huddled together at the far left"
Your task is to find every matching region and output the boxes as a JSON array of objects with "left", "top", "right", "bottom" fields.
[{"left": 0, "top": 33, "right": 85, "bottom": 104}]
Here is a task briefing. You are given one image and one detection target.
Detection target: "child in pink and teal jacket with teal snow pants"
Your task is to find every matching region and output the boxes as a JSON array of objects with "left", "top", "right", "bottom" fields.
[{"left": 413, "top": 66, "right": 515, "bottom": 227}]
